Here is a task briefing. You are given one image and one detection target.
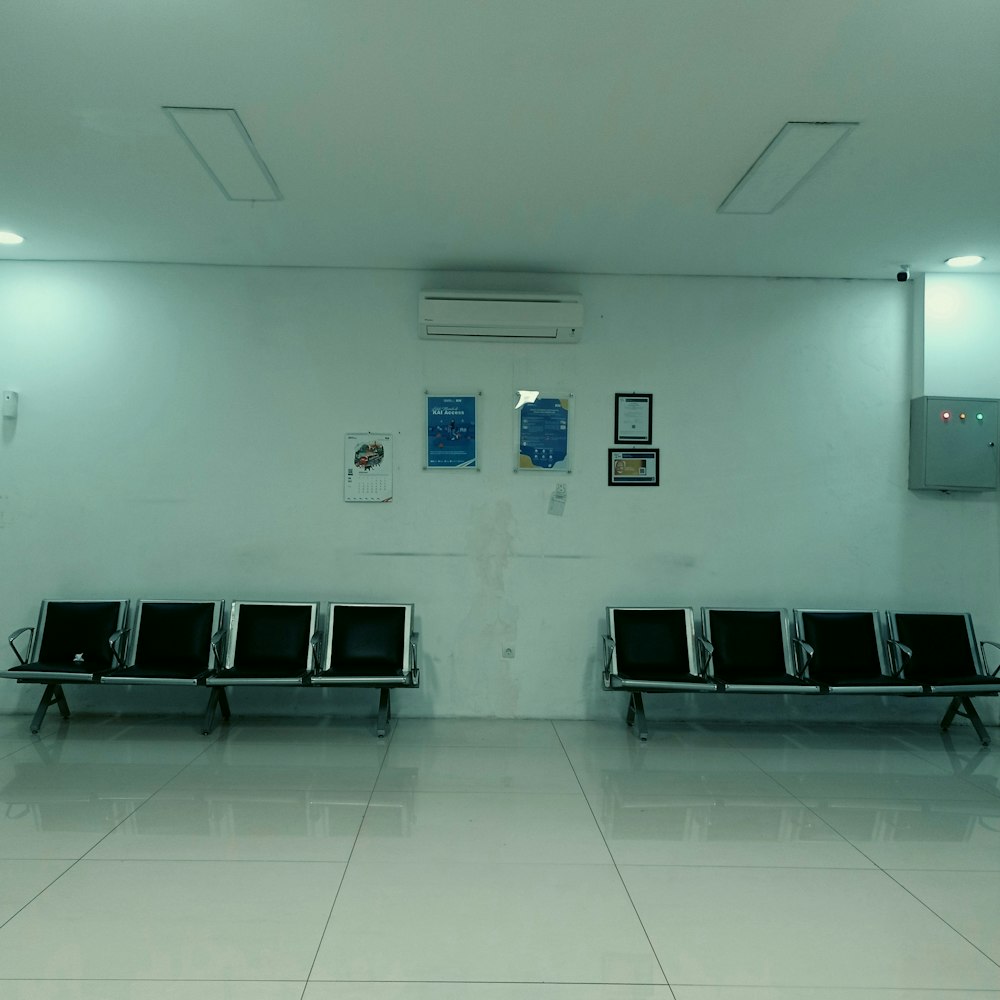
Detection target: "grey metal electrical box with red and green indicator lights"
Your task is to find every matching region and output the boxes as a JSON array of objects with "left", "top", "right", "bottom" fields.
[{"left": 910, "top": 396, "right": 1000, "bottom": 492}]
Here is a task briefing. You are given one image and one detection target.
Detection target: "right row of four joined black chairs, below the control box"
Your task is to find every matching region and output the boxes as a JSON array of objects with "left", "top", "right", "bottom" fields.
[{"left": 603, "top": 607, "right": 1000, "bottom": 746}]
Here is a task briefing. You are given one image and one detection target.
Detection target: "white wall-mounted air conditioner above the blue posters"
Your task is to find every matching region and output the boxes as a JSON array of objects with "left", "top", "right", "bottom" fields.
[{"left": 420, "top": 292, "right": 583, "bottom": 344}]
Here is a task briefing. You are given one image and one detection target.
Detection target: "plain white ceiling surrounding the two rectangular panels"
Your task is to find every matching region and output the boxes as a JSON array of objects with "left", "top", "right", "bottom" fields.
[{"left": 0, "top": 0, "right": 1000, "bottom": 278}]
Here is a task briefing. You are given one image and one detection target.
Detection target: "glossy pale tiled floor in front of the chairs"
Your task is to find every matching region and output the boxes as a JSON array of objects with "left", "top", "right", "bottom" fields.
[{"left": 0, "top": 717, "right": 1000, "bottom": 1000}]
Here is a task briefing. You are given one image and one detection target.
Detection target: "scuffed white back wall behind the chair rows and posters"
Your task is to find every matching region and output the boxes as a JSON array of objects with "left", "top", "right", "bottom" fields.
[{"left": 0, "top": 263, "right": 1000, "bottom": 719}]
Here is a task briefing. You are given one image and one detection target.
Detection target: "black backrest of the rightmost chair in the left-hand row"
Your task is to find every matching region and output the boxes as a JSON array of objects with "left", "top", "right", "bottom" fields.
[{"left": 323, "top": 603, "right": 413, "bottom": 678}]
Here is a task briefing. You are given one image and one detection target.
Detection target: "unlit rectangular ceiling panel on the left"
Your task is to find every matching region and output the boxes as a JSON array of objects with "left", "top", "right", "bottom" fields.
[{"left": 163, "top": 108, "right": 282, "bottom": 201}]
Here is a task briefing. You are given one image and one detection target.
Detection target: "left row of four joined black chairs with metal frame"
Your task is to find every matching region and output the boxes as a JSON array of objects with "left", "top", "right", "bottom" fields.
[{"left": 0, "top": 600, "right": 420, "bottom": 737}]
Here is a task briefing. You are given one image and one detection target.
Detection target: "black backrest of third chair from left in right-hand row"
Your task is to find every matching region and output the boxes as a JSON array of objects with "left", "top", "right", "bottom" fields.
[{"left": 794, "top": 610, "right": 889, "bottom": 684}]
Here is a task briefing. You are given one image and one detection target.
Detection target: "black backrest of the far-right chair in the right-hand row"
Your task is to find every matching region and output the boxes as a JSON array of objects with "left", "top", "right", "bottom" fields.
[{"left": 888, "top": 611, "right": 983, "bottom": 684}]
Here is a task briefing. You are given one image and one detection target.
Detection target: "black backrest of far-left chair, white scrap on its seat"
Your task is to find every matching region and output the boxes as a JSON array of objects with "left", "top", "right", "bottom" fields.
[{"left": 33, "top": 601, "right": 128, "bottom": 668}]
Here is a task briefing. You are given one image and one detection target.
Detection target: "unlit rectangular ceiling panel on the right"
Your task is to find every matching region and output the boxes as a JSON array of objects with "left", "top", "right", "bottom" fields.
[{"left": 718, "top": 122, "right": 858, "bottom": 215}]
